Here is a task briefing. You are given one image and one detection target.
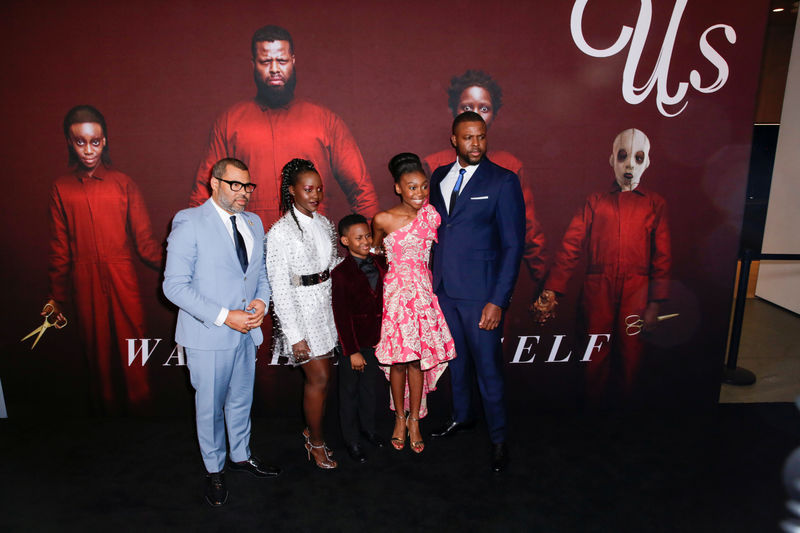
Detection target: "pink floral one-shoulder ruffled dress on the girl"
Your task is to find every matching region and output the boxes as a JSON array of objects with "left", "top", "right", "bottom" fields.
[{"left": 375, "top": 204, "right": 456, "bottom": 417}]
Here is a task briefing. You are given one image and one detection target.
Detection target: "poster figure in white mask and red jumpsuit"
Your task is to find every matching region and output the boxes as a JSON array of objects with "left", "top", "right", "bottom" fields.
[{"left": 534, "top": 129, "right": 671, "bottom": 407}]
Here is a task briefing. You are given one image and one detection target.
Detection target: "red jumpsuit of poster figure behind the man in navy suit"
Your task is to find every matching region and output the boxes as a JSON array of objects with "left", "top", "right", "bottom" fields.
[{"left": 422, "top": 149, "right": 546, "bottom": 285}]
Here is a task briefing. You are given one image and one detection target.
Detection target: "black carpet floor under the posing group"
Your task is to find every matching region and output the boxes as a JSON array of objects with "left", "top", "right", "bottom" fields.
[{"left": 0, "top": 404, "right": 800, "bottom": 533}]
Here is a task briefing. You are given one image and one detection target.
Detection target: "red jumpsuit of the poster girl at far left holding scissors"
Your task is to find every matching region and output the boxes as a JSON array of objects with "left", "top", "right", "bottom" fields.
[{"left": 49, "top": 164, "right": 162, "bottom": 413}]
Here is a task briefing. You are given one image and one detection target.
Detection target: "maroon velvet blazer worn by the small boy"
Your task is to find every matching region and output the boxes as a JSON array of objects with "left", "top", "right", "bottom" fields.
[{"left": 331, "top": 253, "right": 386, "bottom": 357}]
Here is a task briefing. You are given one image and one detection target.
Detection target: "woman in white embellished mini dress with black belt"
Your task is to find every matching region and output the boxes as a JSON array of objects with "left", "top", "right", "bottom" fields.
[{"left": 266, "top": 159, "right": 340, "bottom": 469}]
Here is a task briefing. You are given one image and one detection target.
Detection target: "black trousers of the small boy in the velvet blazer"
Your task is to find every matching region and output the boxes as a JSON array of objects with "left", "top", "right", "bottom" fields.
[{"left": 338, "top": 348, "right": 381, "bottom": 443}]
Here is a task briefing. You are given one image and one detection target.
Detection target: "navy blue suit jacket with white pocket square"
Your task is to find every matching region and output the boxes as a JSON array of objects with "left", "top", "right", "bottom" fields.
[{"left": 430, "top": 157, "right": 525, "bottom": 308}]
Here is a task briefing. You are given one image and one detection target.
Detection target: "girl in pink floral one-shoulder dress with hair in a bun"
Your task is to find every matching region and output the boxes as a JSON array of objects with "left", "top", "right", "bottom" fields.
[{"left": 372, "top": 153, "right": 456, "bottom": 453}]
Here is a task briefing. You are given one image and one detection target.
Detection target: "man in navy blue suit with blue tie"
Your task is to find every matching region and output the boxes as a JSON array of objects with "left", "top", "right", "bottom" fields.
[{"left": 430, "top": 111, "right": 525, "bottom": 472}]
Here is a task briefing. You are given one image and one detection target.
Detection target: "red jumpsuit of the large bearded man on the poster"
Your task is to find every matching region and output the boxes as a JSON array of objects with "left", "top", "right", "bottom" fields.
[{"left": 189, "top": 100, "right": 379, "bottom": 228}]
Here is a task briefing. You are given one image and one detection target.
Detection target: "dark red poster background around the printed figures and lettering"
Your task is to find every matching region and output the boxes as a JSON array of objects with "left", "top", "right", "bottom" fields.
[{"left": 0, "top": 0, "right": 767, "bottom": 416}]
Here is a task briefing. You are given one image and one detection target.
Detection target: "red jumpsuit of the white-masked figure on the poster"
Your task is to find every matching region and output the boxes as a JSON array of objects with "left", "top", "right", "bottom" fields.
[{"left": 545, "top": 183, "right": 671, "bottom": 399}]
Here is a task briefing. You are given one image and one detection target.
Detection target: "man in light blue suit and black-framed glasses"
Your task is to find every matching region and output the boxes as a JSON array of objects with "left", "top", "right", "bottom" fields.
[{"left": 164, "top": 158, "right": 280, "bottom": 506}]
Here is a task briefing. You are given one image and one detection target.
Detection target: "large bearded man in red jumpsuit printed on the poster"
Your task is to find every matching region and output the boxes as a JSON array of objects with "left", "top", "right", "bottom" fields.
[{"left": 189, "top": 26, "right": 379, "bottom": 228}]
